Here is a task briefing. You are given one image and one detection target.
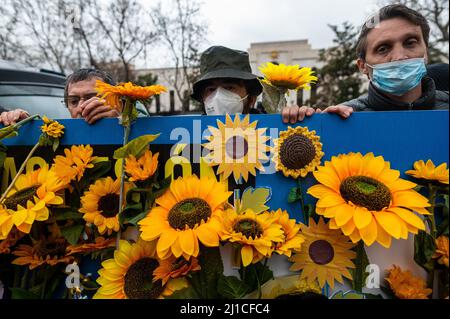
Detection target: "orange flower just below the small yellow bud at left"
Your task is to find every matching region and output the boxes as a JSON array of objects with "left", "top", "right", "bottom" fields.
[{"left": 53, "top": 145, "right": 97, "bottom": 185}]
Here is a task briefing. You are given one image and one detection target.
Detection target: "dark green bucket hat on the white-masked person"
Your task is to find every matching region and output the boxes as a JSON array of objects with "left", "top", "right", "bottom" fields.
[{"left": 191, "top": 46, "right": 263, "bottom": 102}]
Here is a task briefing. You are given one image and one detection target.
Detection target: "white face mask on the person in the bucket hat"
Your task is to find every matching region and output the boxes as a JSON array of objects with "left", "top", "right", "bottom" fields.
[{"left": 205, "top": 87, "right": 248, "bottom": 115}]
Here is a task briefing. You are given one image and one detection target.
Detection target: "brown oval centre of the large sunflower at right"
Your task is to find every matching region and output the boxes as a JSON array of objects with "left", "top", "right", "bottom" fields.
[{"left": 340, "top": 176, "right": 392, "bottom": 211}]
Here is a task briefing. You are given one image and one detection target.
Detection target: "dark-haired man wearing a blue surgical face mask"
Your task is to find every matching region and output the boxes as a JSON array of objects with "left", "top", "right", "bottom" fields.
[{"left": 288, "top": 4, "right": 449, "bottom": 118}]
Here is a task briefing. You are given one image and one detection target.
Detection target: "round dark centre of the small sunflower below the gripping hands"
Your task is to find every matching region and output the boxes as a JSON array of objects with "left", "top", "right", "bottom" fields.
[{"left": 280, "top": 134, "right": 316, "bottom": 170}]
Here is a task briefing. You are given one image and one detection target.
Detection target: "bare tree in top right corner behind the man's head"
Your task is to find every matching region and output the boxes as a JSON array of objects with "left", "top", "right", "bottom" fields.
[{"left": 380, "top": 0, "right": 449, "bottom": 63}]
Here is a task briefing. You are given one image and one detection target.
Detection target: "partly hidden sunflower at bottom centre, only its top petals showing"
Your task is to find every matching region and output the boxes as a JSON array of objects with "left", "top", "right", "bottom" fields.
[{"left": 245, "top": 275, "right": 326, "bottom": 299}]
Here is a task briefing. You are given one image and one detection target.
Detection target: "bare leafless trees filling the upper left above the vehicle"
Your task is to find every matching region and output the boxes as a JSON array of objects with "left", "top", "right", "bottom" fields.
[{"left": 0, "top": 0, "right": 157, "bottom": 81}]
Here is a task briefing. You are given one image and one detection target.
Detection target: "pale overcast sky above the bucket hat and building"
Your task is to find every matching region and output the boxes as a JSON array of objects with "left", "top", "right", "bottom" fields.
[{"left": 147, "top": 0, "right": 379, "bottom": 67}]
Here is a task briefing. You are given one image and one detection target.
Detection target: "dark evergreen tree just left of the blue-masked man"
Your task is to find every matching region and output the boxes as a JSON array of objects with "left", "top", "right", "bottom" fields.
[{"left": 316, "top": 22, "right": 364, "bottom": 107}]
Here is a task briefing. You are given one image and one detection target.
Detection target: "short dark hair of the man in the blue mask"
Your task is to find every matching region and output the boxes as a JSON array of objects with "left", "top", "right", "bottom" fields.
[{"left": 356, "top": 4, "right": 430, "bottom": 59}]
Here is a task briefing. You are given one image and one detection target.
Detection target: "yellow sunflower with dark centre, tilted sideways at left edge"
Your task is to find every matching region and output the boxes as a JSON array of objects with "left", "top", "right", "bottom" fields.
[{"left": 0, "top": 165, "right": 64, "bottom": 239}]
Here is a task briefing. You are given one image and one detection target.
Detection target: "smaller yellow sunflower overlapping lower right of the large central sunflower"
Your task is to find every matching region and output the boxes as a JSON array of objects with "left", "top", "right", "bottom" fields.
[{"left": 221, "top": 209, "right": 285, "bottom": 267}]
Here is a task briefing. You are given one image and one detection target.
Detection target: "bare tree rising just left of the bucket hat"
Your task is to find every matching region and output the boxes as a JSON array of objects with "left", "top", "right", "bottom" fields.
[{"left": 150, "top": 0, "right": 208, "bottom": 111}]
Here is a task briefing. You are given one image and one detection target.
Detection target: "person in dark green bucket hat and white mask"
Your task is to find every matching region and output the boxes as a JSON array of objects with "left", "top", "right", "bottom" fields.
[{"left": 192, "top": 46, "right": 314, "bottom": 123}]
